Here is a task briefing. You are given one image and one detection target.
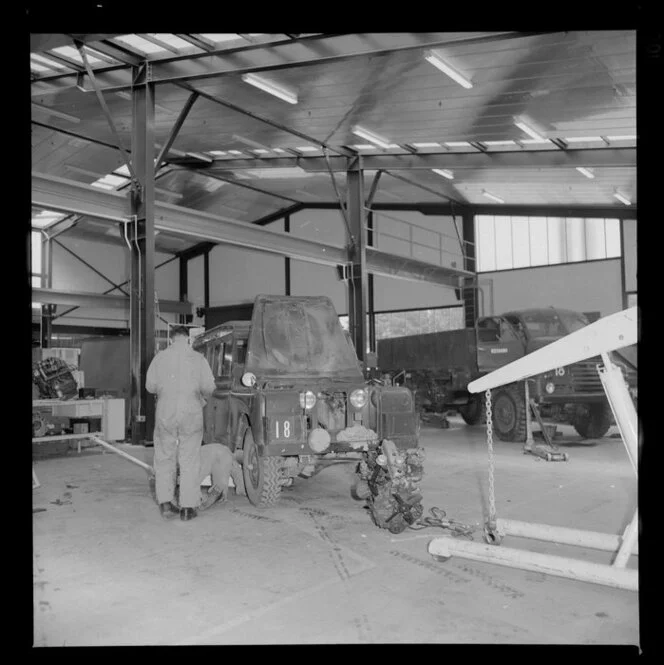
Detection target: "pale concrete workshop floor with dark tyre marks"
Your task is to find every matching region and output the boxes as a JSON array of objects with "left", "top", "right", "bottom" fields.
[{"left": 33, "top": 418, "right": 639, "bottom": 646}]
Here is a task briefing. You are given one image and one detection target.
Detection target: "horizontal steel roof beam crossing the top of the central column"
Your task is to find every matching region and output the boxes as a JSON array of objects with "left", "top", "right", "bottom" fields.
[{"left": 205, "top": 148, "right": 636, "bottom": 172}]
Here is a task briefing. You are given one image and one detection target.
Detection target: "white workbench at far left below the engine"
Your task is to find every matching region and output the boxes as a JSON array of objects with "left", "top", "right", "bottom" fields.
[{"left": 32, "top": 398, "right": 125, "bottom": 452}]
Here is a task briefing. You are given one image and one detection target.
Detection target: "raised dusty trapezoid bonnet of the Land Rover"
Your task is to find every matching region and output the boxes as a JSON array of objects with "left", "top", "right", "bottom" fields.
[{"left": 245, "top": 295, "right": 363, "bottom": 381}]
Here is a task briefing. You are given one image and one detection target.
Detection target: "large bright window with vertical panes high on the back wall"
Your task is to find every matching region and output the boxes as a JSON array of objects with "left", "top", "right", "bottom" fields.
[{"left": 475, "top": 215, "right": 622, "bottom": 272}]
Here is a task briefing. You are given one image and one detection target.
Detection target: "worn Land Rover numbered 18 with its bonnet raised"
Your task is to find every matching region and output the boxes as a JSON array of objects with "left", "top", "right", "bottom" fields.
[{"left": 193, "top": 295, "right": 423, "bottom": 533}]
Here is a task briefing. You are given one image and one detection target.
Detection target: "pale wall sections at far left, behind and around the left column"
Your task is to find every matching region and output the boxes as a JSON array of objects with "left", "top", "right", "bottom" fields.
[{"left": 47, "top": 235, "right": 179, "bottom": 328}]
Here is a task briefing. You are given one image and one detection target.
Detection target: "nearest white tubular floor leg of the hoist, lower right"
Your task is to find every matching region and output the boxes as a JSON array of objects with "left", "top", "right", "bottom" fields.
[{"left": 428, "top": 536, "right": 639, "bottom": 591}]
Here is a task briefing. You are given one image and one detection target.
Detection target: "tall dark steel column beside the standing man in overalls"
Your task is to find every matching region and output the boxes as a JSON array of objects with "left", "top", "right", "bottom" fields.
[{"left": 128, "top": 69, "right": 155, "bottom": 445}]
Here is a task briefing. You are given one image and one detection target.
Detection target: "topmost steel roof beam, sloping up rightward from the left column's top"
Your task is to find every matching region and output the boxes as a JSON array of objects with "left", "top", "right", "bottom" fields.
[{"left": 32, "top": 32, "right": 546, "bottom": 95}]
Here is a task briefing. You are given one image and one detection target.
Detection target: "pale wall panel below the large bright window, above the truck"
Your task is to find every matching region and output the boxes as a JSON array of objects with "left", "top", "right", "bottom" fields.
[{"left": 480, "top": 259, "right": 623, "bottom": 316}]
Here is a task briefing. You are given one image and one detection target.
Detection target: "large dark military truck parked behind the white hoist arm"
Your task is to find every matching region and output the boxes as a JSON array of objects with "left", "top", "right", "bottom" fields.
[{"left": 377, "top": 307, "right": 636, "bottom": 441}]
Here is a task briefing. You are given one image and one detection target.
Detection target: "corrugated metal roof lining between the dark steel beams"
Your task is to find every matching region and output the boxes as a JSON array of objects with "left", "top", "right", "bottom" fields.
[{"left": 31, "top": 30, "right": 636, "bottom": 244}]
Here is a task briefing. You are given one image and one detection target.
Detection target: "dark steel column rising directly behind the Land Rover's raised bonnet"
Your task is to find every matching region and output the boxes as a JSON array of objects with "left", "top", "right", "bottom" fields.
[{"left": 346, "top": 158, "right": 368, "bottom": 361}]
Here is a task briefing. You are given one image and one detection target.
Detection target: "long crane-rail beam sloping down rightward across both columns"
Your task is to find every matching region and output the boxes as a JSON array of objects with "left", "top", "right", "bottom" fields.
[{"left": 32, "top": 173, "right": 471, "bottom": 287}]
